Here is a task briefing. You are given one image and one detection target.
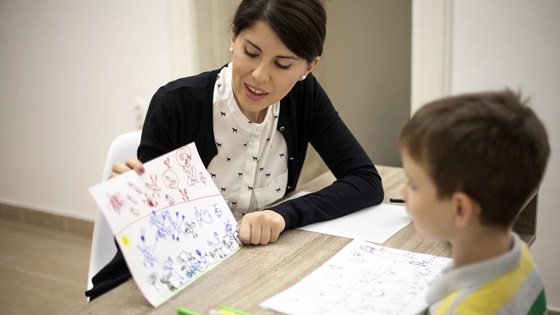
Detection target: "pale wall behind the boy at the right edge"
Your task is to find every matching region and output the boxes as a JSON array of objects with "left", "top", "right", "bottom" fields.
[{"left": 450, "top": 0, "right": 560, "bottom": 311}]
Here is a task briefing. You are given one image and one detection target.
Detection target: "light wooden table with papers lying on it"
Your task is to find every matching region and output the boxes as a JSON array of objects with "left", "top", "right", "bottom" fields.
[{"left": 72, "top": 166, "right": 537, "bottom": 315}]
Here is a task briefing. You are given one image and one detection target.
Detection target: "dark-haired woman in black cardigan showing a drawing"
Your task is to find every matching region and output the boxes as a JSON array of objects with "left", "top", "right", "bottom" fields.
[{"left": 86, "top": 0, "right": 383, "bottom": 298}]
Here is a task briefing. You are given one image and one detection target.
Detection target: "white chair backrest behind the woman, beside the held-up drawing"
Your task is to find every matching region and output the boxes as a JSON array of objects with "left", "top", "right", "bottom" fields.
[{"left": 87, "top": 130, "right": 142, "bottom": 300}]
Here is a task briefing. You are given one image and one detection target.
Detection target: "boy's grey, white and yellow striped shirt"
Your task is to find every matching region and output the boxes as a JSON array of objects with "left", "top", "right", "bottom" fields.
[{"left": 426, "top": 233, "right": 547, "bottom": 315}]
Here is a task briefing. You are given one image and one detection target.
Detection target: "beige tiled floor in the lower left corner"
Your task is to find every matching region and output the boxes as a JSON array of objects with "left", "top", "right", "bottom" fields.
[{"left": 0, "top": 219, "right": 91, "bottom": 315}]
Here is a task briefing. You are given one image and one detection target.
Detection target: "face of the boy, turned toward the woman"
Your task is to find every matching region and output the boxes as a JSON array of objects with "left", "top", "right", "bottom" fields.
[{"left": 401, "top": 149, "right": 454, "bottom": 241}]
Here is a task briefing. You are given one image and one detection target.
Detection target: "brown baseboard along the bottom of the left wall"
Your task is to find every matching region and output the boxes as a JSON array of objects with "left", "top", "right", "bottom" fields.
[{"left": 0, "top": 203, "right": 93, "bottom": 238}]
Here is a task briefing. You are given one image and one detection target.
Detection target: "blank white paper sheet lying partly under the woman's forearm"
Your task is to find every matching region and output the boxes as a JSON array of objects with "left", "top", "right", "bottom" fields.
[{"left": 293, "top": 192, "right": 411, "bottom": 243}]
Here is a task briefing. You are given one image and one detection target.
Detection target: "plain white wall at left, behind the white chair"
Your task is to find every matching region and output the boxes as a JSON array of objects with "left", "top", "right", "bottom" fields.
[{"left": 0, "top": 0, "right": 170, "bottom": 220}]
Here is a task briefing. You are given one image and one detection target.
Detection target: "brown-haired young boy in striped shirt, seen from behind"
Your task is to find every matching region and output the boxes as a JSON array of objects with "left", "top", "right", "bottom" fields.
[{"left": 399, "top": 90, "right": 550, "bottom": 315}]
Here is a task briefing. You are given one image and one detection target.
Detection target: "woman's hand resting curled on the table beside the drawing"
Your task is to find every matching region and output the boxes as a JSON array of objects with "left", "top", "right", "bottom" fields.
[{"left": 239, "top": 210, "right": 286, "bottom": 245}]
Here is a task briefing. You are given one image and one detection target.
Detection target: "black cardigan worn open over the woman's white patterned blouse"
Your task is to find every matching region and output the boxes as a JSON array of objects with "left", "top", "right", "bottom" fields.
[{"left": 86, "top": 69, "right": 383, "bottom": 299}]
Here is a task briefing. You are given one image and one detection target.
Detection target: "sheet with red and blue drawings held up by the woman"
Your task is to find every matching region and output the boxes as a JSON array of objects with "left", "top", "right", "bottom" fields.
[{"left": 90, "top": 143, "right": 242, "bottom": 307}]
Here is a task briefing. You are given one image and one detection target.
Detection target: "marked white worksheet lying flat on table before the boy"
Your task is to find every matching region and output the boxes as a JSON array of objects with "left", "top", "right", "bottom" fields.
[{"left": 260, "top": 240, "right": 451, "bottom": 315}]
